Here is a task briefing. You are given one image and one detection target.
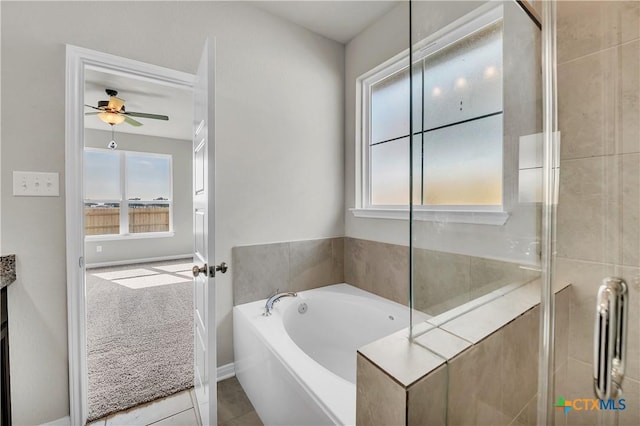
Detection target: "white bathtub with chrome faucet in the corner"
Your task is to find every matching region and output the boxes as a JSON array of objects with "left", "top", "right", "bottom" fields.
[{"left": 233, "top": 284, "right": 409, "bottom": 426}]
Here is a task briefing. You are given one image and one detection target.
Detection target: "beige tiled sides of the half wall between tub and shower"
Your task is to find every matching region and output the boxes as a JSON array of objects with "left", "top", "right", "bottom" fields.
[{"left": 356, "top": 287, "right": 571, "bottom": 426}]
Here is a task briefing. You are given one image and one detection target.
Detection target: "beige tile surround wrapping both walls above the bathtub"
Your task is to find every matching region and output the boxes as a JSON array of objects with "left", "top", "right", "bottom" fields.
[{"left": 232, "top": 237, "right": 537, "bottom": 315}]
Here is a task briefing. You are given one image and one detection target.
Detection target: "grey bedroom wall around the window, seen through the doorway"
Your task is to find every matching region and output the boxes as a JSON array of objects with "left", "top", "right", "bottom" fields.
[{"left": 84, "top": 129, "right": 193, "bottom": 265}]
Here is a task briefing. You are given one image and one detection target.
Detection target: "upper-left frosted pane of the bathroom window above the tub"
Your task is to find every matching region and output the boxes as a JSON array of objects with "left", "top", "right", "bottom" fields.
[{"left": 370, "top": 63, "right": 422, "bottom": 144}]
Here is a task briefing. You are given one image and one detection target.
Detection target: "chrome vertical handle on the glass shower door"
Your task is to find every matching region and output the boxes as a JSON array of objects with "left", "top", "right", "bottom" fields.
[{"left": 593, "top": 277, "right": 628, "bottom": 400}]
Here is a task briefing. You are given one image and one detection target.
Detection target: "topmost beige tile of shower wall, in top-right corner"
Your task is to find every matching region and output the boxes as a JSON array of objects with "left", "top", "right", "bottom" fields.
[{"left": 557, "top": 1, "right": 640, "bottom": 63}]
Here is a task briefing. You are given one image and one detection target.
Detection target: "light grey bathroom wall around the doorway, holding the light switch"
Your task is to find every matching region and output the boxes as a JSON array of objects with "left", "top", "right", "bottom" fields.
[{"left": 0, "top": 2, "right": 344, "bottom": 425}]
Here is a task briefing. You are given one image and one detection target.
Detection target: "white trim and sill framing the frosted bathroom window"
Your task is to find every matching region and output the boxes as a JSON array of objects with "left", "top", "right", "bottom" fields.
[{"left": 349, "top": 3, "right": 510, "bottom": 225}]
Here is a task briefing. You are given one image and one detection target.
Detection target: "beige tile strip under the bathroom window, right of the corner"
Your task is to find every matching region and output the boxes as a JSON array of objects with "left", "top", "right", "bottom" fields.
[{"left": 344, "top": 238, "right": 538, "bottom": 315}]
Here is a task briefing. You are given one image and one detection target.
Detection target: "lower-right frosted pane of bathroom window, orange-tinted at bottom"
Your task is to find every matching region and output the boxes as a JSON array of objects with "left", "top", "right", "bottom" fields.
[{"left": 424, "top": 115, "right": 502, "bottom": 205}]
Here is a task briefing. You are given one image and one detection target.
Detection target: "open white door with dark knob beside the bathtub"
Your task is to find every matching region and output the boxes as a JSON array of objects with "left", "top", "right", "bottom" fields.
[{"left": 193, "top": 41, "right": 217, "bottom": 426}]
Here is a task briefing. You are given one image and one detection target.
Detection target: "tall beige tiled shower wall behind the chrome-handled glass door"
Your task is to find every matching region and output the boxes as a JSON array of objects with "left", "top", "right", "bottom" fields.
[{"left": 555, "top": 1, "right": 640, "bottom": 425}]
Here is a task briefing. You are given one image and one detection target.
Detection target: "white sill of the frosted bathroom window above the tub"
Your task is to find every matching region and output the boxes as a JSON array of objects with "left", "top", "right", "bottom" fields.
[{"left": 349, "top": 209, "right": 509, "bottom": 226}]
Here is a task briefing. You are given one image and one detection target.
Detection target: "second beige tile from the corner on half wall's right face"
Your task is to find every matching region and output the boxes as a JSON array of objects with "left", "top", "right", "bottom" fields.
[{"left": 447, "top": 332, "right": 511, "bottom": 426}]
